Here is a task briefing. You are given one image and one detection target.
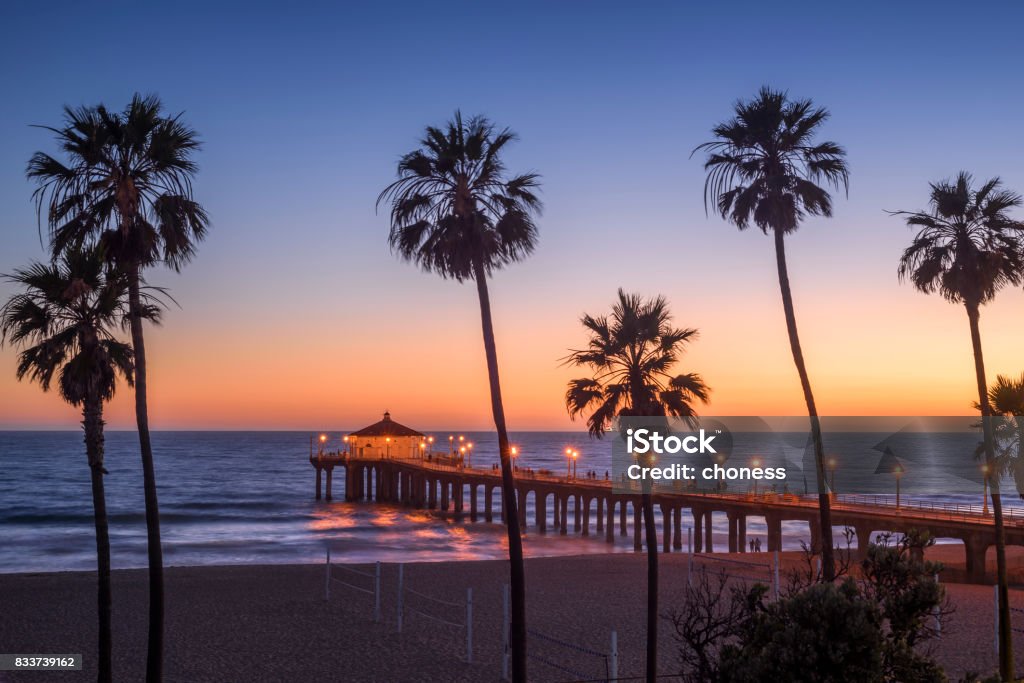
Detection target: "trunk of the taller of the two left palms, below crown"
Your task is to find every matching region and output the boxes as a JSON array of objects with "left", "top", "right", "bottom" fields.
[{"left": 128, "top": 263, "right": 164, "bottom": 683}]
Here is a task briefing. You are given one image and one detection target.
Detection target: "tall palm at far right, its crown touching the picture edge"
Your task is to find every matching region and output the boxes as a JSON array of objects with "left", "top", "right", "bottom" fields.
[{"left": 892, "top": 171, "right": 1024, "bottom": 681}]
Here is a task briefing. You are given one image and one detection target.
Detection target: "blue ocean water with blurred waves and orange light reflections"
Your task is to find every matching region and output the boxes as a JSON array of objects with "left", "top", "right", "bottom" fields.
[{"left": 0, "top": 430, "right": 1011, "bottom": 572}]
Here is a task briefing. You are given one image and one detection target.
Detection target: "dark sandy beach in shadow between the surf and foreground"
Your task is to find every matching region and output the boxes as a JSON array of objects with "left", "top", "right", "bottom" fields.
[{"left": 0, "top": 553, "right": 1024, "bottom": 682}]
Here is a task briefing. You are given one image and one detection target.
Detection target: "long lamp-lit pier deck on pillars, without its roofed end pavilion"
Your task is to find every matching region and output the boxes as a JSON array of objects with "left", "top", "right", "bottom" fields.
[{"left": 309, "top": 454, "right": 1024, "bottom": 583}]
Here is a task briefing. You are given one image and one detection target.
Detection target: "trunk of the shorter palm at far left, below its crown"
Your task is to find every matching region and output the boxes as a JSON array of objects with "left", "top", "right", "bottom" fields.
[{"left": 82, "top": 398, "right": 113, "bottom": 683}]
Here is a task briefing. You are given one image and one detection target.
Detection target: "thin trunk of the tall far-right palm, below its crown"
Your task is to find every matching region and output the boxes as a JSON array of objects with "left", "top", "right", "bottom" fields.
[{"left": 967, "top": 303, "right": 1014, "bottom": 681}]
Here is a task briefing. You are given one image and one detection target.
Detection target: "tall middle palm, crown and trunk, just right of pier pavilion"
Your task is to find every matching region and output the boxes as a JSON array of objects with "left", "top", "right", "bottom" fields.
[{"left": 377, "top": 112, "right": 541, "bottom": 683}]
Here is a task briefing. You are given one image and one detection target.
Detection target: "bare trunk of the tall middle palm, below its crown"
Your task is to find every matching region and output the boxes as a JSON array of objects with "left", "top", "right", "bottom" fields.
[{"left": 473, "top": 261, "right": 526, "bottom": 683}]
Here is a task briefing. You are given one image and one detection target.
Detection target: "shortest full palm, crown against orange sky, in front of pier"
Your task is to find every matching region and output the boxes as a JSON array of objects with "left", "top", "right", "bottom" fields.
[{"left": 565, "top": 290, "right": 711, "bottom": 681}]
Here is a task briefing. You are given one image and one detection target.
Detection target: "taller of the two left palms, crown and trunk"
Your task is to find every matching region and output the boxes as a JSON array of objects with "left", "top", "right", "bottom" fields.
[{"left": 28, "top": 94, "right": 208, "bottom": 681}]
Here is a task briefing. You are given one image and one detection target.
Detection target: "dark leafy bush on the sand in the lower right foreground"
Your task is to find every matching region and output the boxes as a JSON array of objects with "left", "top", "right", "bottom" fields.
[{"left": 671, "top": 532, "right": 952, "bottom": 683}]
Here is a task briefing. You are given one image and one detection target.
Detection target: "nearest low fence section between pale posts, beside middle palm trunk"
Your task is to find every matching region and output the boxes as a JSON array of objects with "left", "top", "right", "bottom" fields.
[{"left": 502, "top": 584, "right": 618, "bottom": 683}]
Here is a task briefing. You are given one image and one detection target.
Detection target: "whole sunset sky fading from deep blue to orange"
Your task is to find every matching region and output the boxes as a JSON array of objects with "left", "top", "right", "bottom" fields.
[{"left": 0, "top": 1, "right": 1024, "bottom": 431}]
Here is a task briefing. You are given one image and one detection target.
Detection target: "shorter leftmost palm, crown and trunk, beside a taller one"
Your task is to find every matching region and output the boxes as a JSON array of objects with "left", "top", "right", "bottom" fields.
[{"left": 0, "top": 251, "right": 141, "bottom": 681}]
